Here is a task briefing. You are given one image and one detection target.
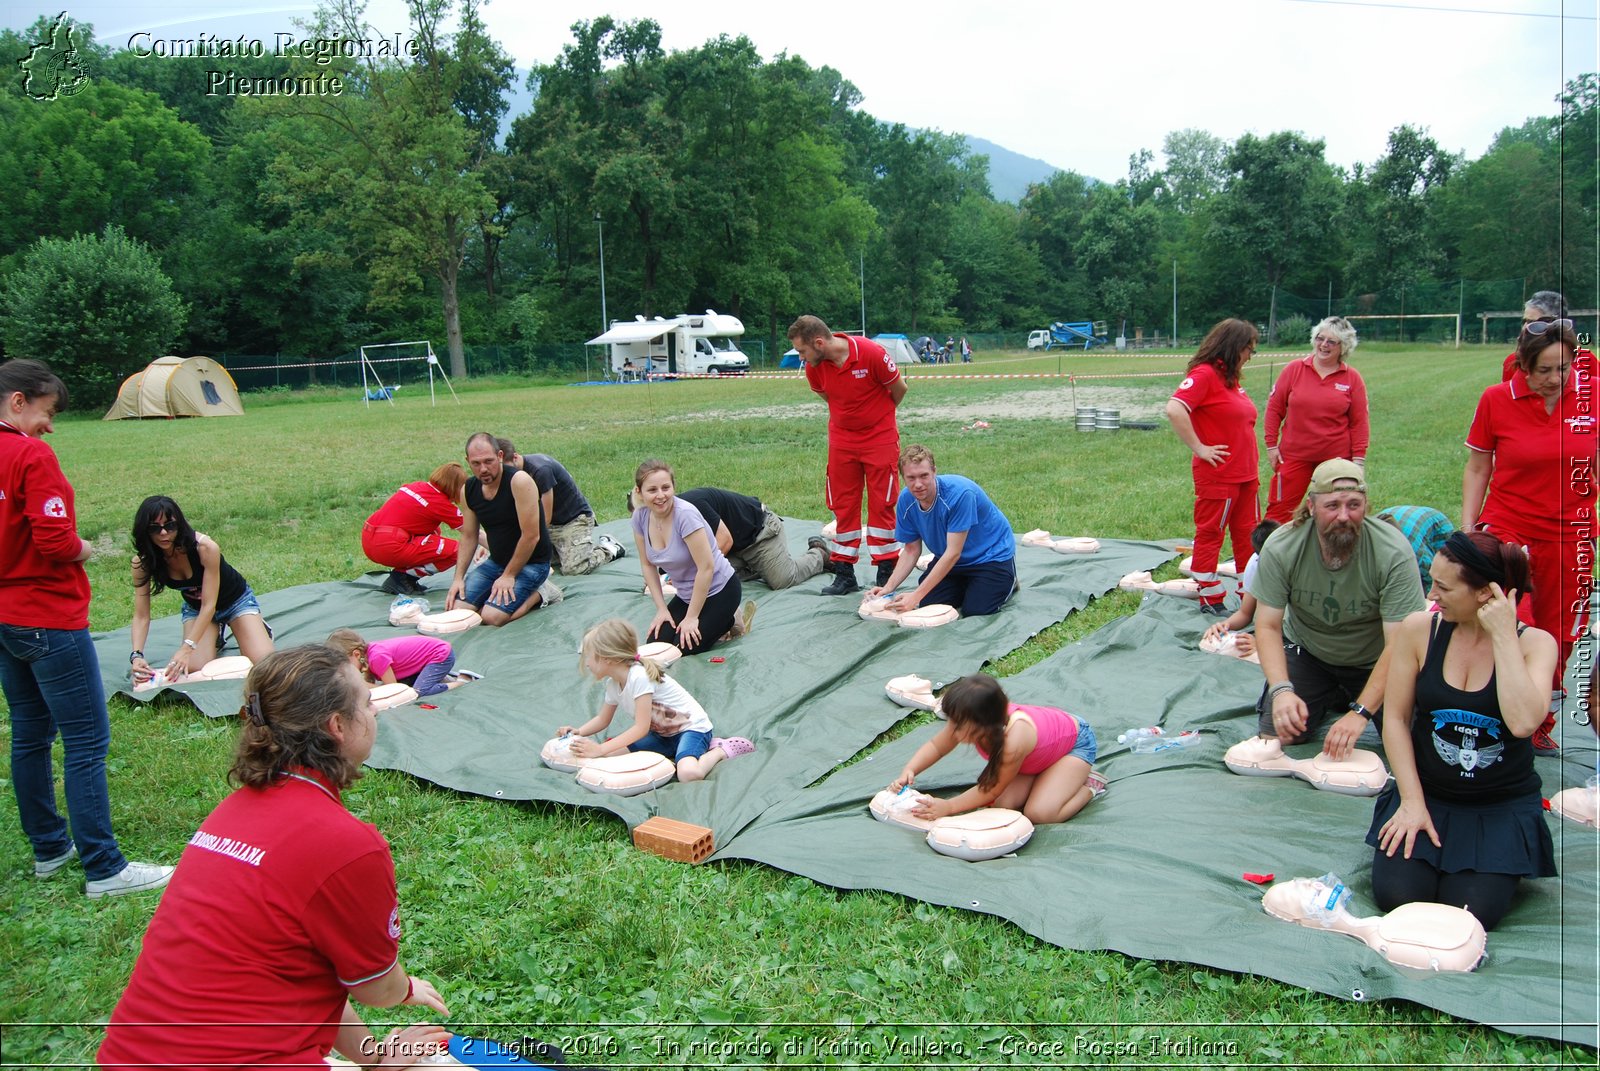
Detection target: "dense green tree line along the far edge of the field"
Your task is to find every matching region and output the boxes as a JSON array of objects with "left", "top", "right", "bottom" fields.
[{"left": 0, "top": 0, "right": 1600, "bottom": 397}]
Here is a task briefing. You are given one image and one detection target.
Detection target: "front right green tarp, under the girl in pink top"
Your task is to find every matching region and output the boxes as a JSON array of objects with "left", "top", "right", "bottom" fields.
[{"left": 717, "top": 596, "right": 1600, "bottom": 1047}]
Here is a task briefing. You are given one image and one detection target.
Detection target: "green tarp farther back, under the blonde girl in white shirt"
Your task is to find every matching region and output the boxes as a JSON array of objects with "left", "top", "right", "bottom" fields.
[{"left": 96, "top": 520, "right": 1173, "bottom": 844}]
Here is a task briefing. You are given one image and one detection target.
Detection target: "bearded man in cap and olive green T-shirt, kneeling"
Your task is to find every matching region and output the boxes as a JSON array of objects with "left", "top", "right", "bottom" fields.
[{"left": 1250, "top": 458, "right": 1422, "bottom": 760}]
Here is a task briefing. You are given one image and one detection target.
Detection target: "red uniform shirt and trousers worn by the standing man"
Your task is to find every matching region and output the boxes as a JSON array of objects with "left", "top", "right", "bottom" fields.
[{"left": 805, "top": 333, "right": 899, "bottom": 565}]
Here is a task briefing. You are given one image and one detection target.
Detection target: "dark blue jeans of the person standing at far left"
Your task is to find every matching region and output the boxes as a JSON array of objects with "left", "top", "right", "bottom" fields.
[{"left": 0, "top": 624, "right": 128, "bottom": 880}]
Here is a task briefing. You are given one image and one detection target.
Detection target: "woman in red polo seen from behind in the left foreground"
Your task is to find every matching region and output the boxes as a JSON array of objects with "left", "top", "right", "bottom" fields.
[{"left": 99, "top": 645, "right": 450, "bottom": 1071}]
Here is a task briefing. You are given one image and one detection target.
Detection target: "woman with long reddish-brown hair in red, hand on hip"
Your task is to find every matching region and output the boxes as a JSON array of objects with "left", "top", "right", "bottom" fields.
[{"left": 1166, "top": 320, "right": 1261, "bottom": 616}]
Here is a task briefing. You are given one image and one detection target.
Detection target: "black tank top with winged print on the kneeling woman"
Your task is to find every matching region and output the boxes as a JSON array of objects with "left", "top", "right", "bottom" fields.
[{"left": 1411, "top": 616, "right": 1539, "bottom": 804}]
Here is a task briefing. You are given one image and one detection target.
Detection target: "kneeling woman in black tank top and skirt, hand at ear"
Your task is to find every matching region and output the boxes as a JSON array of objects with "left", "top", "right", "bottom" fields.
[{"left": 1366, "top": 531, "right": 1555, "bottom": 930}]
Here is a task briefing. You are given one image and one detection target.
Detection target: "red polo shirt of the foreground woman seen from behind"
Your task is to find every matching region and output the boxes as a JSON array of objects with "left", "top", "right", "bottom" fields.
[{"left": 99, "top": 770, "right": 400, "bottom": 1071}]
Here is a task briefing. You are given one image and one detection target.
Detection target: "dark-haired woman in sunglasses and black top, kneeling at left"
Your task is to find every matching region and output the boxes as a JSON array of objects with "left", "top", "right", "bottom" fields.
[{"left": 128, "top": 495, "right": 272, "bottom": 684}]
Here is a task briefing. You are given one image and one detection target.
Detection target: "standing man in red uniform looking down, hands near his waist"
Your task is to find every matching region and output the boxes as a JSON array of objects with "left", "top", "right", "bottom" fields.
[{"left": 789, "top": 315, "right": 906, "bottom": 596}]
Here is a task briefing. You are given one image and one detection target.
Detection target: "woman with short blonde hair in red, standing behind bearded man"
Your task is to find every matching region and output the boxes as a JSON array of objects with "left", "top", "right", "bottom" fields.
[{"left": 1266, "top": 315, "right": 1370, "bottom": 523}]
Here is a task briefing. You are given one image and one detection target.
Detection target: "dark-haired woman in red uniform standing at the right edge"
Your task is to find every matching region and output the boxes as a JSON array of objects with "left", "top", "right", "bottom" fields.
[{"left": 1461, "top": 320, "right": 1595, "bottom": 752}]
